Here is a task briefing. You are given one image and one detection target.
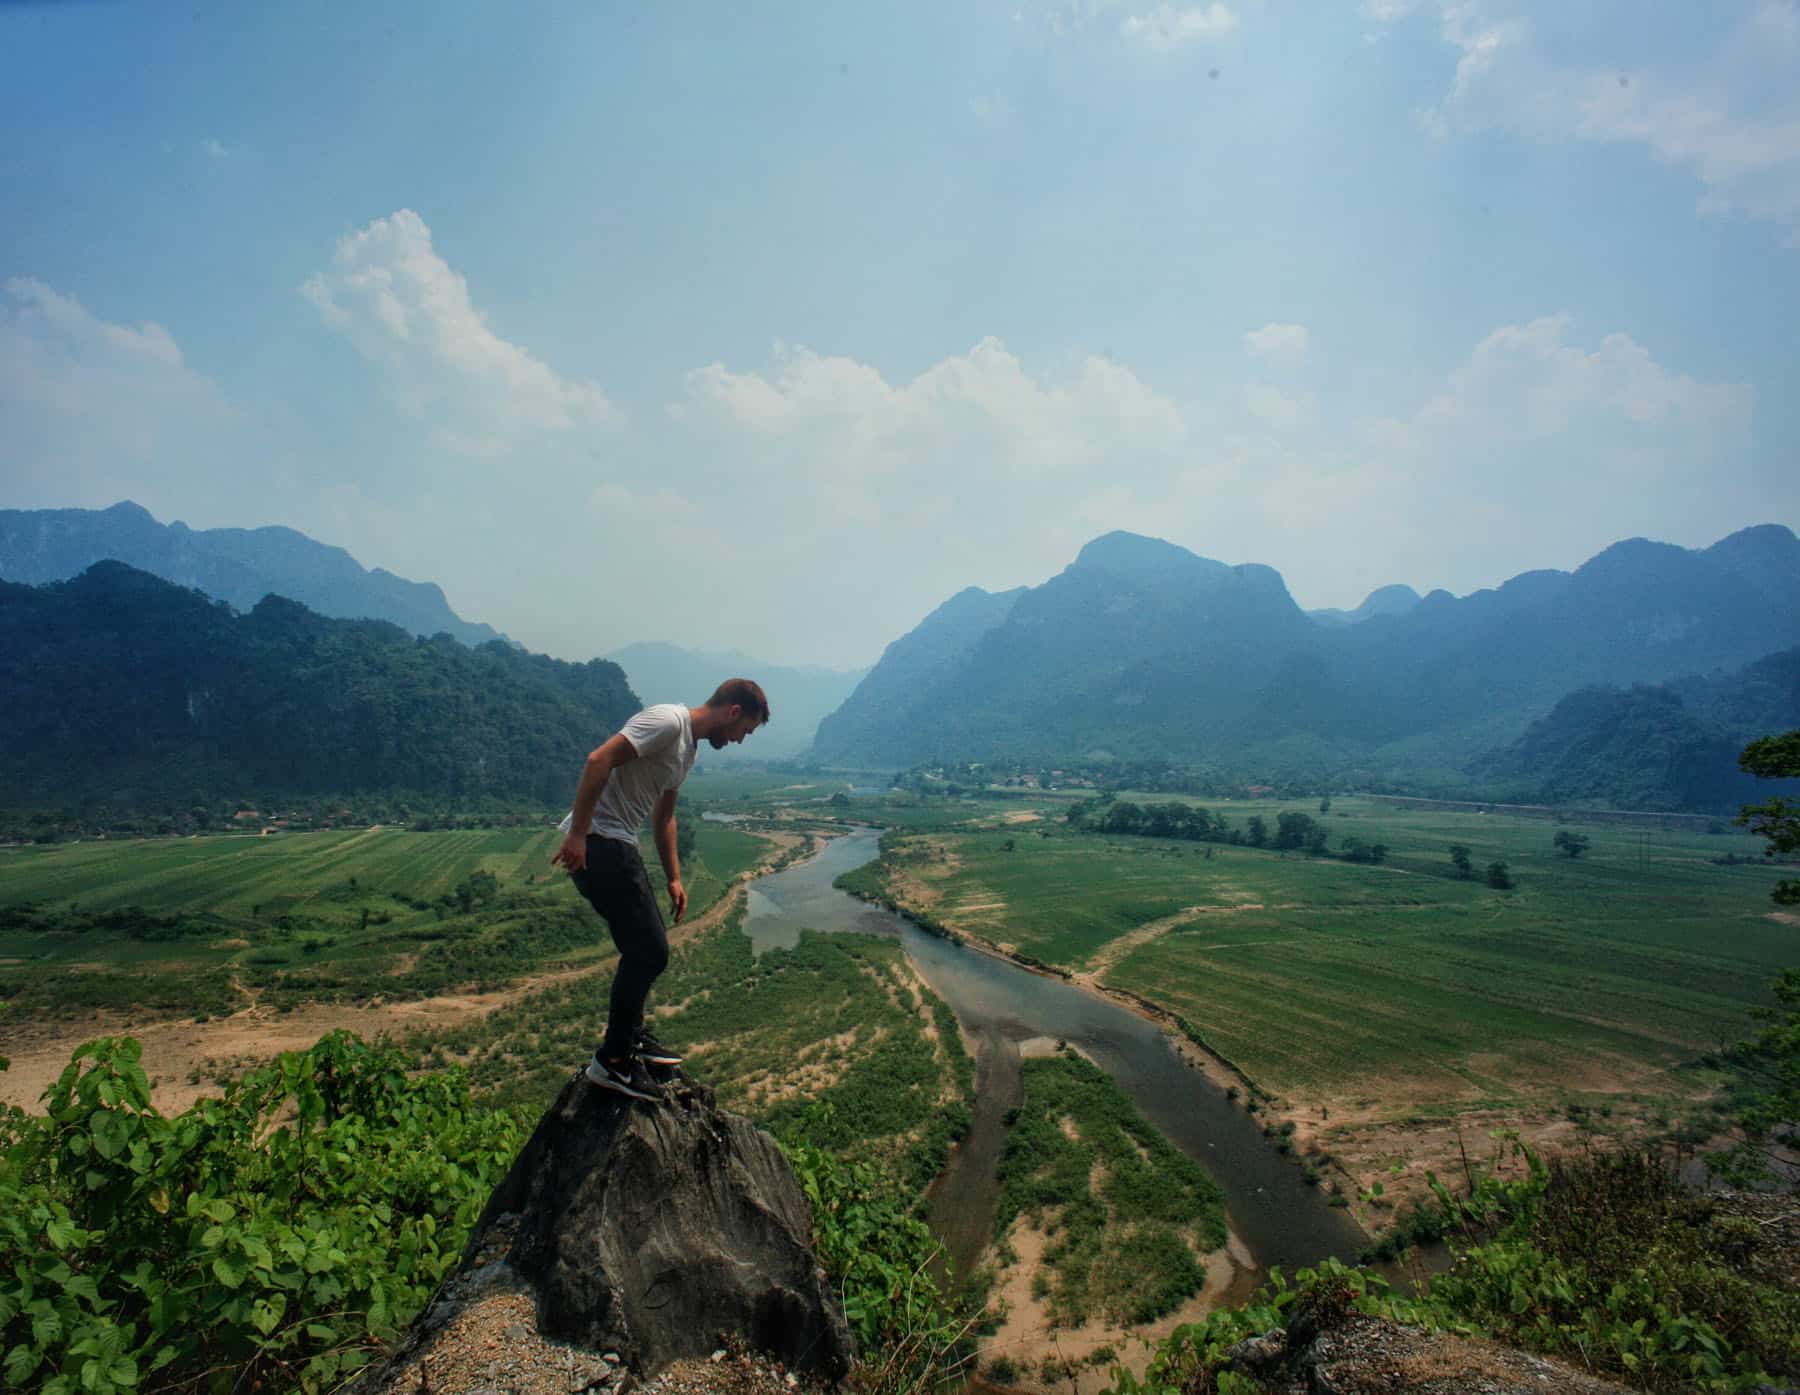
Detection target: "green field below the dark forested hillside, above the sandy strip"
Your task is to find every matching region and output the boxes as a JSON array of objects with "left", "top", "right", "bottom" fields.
[{"left": 0, "top": 824, "right": 769, "bottom": 1015}]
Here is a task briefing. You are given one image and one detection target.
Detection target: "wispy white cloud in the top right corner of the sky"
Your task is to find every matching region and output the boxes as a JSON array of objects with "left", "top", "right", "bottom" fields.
[{"left": 1404, "top": 0, "right": 1800, "bottom": 245}]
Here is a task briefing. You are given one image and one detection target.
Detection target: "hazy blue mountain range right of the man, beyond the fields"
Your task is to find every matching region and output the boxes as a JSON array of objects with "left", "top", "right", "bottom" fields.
[{"left": 814, "top": 524, "right": 1800, "bottom": 806}]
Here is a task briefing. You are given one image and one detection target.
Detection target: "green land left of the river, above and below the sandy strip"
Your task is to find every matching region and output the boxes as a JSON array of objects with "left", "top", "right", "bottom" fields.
[{"left": 0, "top": 813, "right": 974, "bottom": 1192}]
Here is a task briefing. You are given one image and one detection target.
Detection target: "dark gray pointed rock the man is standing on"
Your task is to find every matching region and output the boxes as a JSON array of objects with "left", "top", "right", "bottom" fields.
[{"left": 464, "top": 1073, "right": 855, "bottom": 1381}]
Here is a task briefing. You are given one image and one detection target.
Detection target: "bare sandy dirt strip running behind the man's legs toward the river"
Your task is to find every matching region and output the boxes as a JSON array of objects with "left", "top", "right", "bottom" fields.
[{"left": 0, "top": 833, "right": 814, "bottom": 1114}]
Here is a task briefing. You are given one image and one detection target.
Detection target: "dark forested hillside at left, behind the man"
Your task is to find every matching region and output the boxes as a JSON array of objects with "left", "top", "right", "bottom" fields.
[{"left": 0, "top": 562, "right": 637, "bottom": 810}]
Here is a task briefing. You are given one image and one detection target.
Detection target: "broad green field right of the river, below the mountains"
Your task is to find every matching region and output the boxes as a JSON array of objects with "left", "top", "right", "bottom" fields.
[{"left": 864, "top": 796, "right": 1800, "bottom": 1103}]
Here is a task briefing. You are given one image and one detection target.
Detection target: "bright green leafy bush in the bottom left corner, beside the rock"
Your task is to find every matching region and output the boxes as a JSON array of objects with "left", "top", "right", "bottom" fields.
[{"left": 0, "top": 1031, "right": 520, "bottom": 1395}]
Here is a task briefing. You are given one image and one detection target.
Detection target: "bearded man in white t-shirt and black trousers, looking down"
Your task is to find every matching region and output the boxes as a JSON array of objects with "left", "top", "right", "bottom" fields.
[{"left": 551, "top": 679, "right": 769, "bottom": 1100}]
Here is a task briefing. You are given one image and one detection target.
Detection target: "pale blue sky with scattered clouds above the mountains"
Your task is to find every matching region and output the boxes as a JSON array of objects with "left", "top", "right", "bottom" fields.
[{"left": 0, "top": 0, "right": 1800, "bottom": 664}]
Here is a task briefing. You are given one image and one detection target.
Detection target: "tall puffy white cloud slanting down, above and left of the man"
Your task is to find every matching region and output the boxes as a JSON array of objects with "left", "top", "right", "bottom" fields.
[{"left": 301, "top": 209, "right": 621, "bottom": 457}]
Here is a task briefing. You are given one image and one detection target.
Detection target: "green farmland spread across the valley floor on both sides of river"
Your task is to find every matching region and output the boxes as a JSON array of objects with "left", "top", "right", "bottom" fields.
[{"left": 0, "top": 792, "right": 1796, "bottom": 1238}]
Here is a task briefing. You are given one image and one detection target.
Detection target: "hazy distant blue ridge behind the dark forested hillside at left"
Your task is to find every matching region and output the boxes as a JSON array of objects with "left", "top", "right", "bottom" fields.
[{"left": 0, "top": 500, "right": 502, "bottom": 644}]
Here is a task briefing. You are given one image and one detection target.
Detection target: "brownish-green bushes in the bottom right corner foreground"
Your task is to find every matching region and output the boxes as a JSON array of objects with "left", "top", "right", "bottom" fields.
[{"left": 1112, "top": 1145, "right": 1800, "bottom": 1395}]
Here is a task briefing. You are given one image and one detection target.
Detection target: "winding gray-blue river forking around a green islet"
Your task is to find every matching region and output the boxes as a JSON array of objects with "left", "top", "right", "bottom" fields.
[{"left": 743, "top": 830, "right": 1368, "bottom": 1296}]
